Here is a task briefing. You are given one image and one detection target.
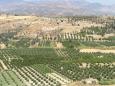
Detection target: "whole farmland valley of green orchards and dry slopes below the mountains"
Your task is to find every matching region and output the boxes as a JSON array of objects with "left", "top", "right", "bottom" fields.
[{"left": 0, "top": 15, "right": 115, "bottom": 86}]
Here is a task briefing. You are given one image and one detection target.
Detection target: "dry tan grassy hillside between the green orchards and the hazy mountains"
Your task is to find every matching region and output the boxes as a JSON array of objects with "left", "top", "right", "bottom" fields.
[{"left": 0, "top": 16, "right": 103, "bottom": 37}]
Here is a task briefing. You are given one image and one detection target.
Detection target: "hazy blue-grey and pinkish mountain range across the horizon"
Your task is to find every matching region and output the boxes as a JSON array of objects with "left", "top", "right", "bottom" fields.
[{"left": 0, "top": 0, "right": 115, "bottom": 16}]
